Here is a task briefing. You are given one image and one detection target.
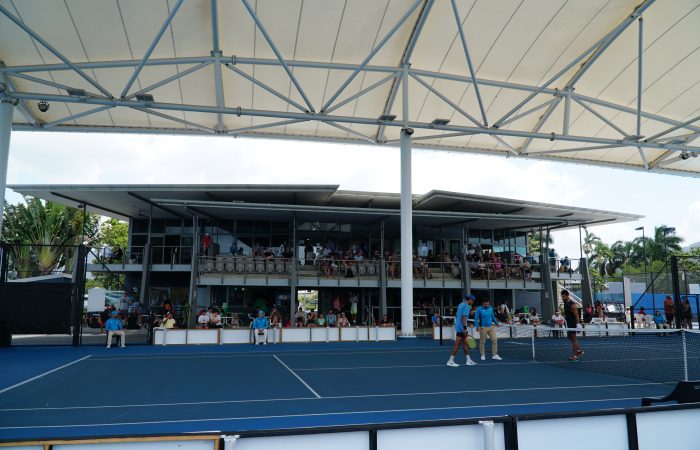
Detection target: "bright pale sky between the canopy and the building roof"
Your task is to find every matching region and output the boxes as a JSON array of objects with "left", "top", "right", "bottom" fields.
[{"left": 6, "top": 132, "right": 700, "bottom": 258}]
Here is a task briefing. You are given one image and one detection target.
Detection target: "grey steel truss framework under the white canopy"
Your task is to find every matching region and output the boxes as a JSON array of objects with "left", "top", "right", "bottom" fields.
[{"left": 0, "top": 0, "right": 700, "bottom": 175}]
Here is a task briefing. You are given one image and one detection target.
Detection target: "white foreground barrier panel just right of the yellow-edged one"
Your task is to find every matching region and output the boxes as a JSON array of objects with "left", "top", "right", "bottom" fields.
[{"left": 234, "top": 431, "right": 369, "bottom": 450}]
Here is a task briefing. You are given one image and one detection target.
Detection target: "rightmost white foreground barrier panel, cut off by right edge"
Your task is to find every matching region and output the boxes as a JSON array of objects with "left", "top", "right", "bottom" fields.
[{"left": 637, "top": 409, "right": 700, "bottom": 450}]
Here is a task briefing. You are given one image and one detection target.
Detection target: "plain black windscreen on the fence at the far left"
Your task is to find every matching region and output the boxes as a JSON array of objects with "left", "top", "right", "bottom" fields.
[{"left": 0, "top": 283, "right": 72, "bottom": 334}]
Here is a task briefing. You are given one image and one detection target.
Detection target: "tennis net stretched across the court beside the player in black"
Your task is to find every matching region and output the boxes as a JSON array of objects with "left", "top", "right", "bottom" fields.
[{"left": 499, "top": 328, "right": 700, "bottom": 383}]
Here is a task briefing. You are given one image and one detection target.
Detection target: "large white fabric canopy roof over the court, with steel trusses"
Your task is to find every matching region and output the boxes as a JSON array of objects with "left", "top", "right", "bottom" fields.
[{"left": 0, "top": 0, "right": 700, "bottom": 176}]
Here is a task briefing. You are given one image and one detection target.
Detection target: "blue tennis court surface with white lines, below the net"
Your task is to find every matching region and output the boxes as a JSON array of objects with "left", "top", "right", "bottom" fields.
[{"left": 0, "top": 339, "right": 671, "bottom": 440}]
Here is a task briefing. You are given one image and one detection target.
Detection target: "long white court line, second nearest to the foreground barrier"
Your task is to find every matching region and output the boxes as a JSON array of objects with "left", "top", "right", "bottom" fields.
[{"left": 0, "top": 381, "right": 667, "bottom": 412}]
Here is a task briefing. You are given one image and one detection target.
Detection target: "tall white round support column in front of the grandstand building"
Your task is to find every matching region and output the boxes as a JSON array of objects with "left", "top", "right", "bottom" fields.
[{"left": 401, "top": 128, "right": 414, "bottom": 337}]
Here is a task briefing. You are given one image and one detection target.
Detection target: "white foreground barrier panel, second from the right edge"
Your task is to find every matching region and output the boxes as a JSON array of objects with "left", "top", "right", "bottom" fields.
[{"left": 518, "top": 411, "right": 628, "bottom": 450}]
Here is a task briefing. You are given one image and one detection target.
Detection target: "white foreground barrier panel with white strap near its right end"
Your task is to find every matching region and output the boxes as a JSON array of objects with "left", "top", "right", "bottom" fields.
[{"left": 377, "top": 423, "right": 504, "bottom": 450}]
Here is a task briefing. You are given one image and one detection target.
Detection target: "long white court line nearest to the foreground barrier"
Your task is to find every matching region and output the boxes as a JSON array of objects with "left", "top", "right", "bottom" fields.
[{"left": 0, "top": 397, "right": 639, "bottom": 430}]
